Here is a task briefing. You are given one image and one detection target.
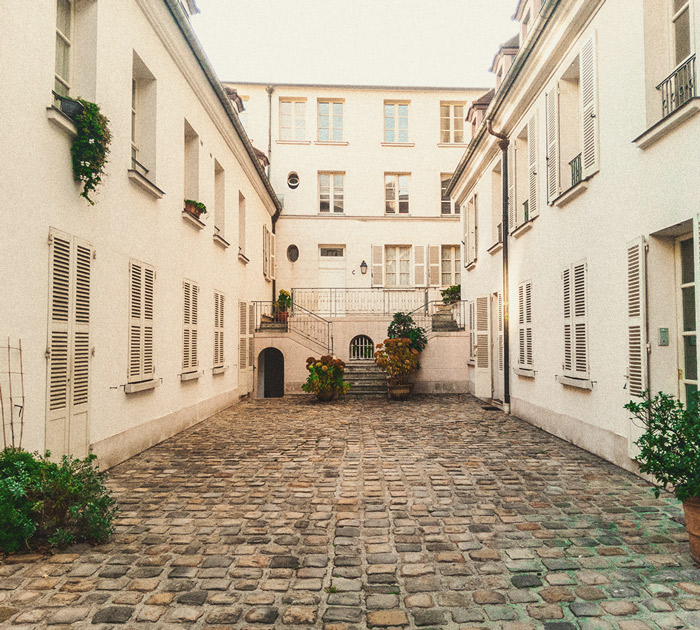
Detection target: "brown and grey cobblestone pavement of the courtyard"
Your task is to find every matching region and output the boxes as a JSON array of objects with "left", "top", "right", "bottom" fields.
[{"left": 0, "top": 396, "right": 700, "bottom": 630}]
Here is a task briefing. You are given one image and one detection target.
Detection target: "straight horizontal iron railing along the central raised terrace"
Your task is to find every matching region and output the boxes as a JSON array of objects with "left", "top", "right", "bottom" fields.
[{"left": 292, "top": 288, "right": 428, "bottom": 317}]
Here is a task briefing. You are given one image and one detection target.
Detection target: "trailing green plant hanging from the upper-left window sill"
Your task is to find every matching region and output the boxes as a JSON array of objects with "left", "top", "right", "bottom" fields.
[{"left": 70, "top": 98, "right": 112, "bottom": 205}]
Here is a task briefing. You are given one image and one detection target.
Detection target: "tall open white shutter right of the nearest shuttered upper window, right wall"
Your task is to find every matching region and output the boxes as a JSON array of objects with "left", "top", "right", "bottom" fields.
[{"left": 579, "top": 36, "right": 600, "bottom": 178}]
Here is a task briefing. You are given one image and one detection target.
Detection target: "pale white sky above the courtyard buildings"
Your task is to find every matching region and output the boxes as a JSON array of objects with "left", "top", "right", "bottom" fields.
[{"left": 192, "top": 0, "right": 518, "bottom": 87}]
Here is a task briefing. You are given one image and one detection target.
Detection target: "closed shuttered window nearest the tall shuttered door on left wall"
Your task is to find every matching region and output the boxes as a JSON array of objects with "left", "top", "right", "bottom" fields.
[{"left": 128, "top": 260, "right": 156, "bottom": 383}]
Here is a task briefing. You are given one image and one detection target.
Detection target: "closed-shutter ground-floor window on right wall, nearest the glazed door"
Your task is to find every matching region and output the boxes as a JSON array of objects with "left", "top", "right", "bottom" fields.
[{"left": 562, "top": 262, "right": 589, "bottom": 379}]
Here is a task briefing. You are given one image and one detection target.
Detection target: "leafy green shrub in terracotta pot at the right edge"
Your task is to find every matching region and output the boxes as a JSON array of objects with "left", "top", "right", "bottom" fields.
[{"left": 625, "top": 392, "right": 700, "bottom": 563}]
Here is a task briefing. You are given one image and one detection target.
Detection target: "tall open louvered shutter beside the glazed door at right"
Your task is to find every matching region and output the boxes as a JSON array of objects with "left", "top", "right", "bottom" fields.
[{"left": 627, "top": 237, "right": 647, "bottom": 396}]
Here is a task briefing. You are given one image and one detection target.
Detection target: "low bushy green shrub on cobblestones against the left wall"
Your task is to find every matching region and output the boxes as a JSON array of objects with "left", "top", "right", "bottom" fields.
[{"left": 0, "top": 448, "right": 117, "bottom": 551}]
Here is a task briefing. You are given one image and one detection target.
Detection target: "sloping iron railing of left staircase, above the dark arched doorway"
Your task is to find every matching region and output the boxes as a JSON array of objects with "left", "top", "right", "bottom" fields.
[{"left": 253, "top": 302, "right": 333, "bottom": 354}]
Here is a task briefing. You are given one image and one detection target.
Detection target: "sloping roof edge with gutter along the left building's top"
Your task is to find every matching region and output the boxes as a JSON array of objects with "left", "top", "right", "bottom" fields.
[{"left": 163, "top": 0, "right": 282, "bottom": 215}]
